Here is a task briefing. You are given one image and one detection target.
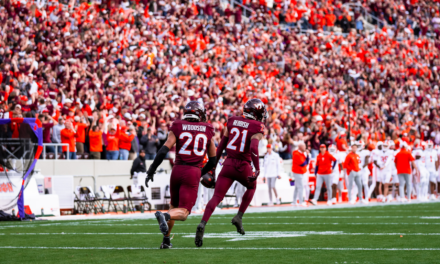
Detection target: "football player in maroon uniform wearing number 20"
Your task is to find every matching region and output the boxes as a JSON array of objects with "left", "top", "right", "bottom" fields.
[{"left": 145, "top": 101, "right": 216, "bottom": 249}]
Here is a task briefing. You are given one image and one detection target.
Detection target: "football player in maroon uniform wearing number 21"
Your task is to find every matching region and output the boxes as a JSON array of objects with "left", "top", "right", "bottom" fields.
[{"left": 195, "top": 99, "right": 267, "bottom": 247}]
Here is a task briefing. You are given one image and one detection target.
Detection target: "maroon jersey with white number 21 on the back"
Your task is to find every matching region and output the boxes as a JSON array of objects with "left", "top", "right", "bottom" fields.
[{"left": 226, "top": 116, "right": 264, "bottom": 162}]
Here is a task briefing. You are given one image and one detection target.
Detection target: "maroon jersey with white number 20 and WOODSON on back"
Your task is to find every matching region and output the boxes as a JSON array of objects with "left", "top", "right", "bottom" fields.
[{"left": 170, "top": 120, "right": 214, "bottom": 167}]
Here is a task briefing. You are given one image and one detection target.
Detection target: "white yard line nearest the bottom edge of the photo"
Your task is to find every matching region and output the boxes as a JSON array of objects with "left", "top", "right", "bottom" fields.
[{"left": 0, "top": 246, "right": 440, "bottom": 251}]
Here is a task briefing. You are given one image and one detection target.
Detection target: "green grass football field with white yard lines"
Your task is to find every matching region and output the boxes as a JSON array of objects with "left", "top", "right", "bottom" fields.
[{"left": 0, "top": 203, "right": 440, "bottom": 263}]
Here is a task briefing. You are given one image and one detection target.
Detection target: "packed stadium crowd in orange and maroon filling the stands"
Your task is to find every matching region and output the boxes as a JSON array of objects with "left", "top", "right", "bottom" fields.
[{"left": 0, "top": 0, "right": 440, "bottom": 162}]
